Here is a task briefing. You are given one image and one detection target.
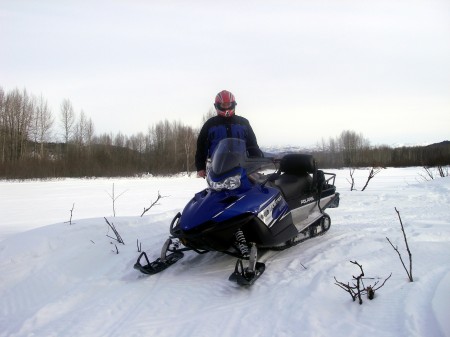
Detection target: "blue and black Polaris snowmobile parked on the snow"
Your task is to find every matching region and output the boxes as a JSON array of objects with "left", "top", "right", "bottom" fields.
[{"left": 134, "top": 138, "right": 339, "bottom": 285}]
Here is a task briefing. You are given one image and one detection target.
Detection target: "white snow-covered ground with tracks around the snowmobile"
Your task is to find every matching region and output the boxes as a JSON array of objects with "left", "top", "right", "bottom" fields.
[{"left": 0, "top": 167, "right": 450, "bottom": 337}]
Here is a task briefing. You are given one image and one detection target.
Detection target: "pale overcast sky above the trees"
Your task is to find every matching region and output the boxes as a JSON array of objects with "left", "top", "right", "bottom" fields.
[{"left": 0, "top": 0, "right": 450, "bottom": 146}]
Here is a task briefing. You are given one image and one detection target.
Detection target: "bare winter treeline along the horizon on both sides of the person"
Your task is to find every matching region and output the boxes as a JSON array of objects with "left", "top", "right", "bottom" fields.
[{"left": 0, "top": 87, "right": 450, "bottom": 179}]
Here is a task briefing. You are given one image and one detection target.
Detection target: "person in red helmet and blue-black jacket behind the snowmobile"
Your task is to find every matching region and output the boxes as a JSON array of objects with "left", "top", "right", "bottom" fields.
[{"left": 195, "top": 90, "right": 262, "bottom": 178}]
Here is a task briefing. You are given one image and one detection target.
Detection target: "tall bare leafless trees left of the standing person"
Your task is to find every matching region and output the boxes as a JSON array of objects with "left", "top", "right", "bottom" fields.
[{"left": 0, "top": 87, "right": 198, "bottom": 179}]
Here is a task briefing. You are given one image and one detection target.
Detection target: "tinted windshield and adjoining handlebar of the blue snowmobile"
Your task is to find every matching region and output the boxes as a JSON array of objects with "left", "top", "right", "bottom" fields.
[{"left": 211, "top": 138, "right": 273, "bottom": 176}]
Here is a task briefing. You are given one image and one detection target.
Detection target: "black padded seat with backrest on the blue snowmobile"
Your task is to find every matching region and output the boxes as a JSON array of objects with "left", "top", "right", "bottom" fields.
[{"left": 275, "top": 153, "right": 316, "bottom": 204}]
